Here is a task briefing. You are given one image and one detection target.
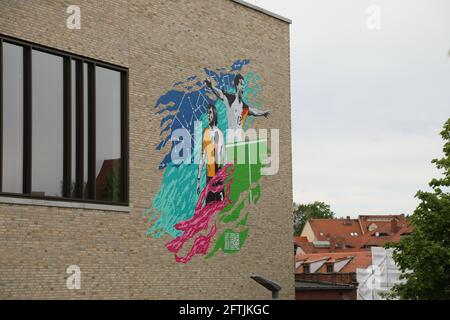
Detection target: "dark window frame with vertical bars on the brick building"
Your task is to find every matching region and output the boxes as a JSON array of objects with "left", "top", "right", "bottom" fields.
[{"left": 0, "top": 34, "right": 130, "bottom": 206}]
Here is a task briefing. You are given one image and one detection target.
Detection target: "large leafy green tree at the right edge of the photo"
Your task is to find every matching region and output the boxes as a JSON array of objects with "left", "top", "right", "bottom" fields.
[{"left": 389, "top": 119, "right": 450, "bottom": 300}]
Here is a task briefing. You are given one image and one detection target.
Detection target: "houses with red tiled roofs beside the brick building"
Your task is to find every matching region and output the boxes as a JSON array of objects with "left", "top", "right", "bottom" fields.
[{"left": 294, "top": 214, "right": 412, "bottom": 300}]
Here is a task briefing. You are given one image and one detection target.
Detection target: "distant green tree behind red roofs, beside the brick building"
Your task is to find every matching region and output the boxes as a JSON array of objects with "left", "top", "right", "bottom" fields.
[{"left": 294, "top": 201, "right": 335, "bottom": 236}]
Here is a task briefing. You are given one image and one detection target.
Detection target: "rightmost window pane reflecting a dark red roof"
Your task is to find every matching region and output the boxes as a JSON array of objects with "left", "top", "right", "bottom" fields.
[{"left": 95, "top": 67, "right": 123, "bottom": 202}]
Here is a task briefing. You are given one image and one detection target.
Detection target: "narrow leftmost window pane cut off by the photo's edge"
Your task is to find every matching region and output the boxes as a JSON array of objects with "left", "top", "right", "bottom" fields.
[{"left": 2, "top": 43, "right": 23, "bottom": 193}]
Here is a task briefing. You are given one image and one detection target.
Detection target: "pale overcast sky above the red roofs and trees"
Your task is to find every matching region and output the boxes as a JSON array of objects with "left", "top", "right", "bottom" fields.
[{"left": 249, "top": 0, "right": 450, "bottom": 217}]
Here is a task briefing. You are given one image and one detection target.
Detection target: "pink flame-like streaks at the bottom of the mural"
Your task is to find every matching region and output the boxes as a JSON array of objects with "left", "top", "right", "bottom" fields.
[{"left": 166, "top": 164, "right": 234, "bottom": 263}]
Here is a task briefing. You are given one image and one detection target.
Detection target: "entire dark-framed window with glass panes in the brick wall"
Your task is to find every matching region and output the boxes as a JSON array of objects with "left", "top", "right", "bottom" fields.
[{"left": 0, "top": 37, "right": 128, "bottom": 204}]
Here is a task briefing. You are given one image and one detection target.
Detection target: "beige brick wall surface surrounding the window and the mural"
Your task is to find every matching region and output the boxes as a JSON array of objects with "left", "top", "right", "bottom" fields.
[{"left": 0, "top": 0, "right": 294, "bottom": 299}]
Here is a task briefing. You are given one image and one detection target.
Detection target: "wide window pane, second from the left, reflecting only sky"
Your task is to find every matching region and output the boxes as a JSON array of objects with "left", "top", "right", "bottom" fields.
[{"left": 32, "top": 50, "right": 63, "bottom": 196}]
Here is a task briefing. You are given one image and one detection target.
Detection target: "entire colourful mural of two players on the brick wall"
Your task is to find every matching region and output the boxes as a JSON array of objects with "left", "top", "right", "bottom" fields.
[{"left": 144, "top": 60, "right": 270, "bottom": 263}]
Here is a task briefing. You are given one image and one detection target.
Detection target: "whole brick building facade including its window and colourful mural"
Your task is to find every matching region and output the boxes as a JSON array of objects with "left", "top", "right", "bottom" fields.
[{"left": 0, "top": 0, "right": 295, "bottom": 299}]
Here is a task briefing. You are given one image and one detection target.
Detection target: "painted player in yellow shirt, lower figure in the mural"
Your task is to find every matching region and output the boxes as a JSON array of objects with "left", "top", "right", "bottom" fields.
[{"left": 197, "top": 105, "right": 225, "bottom": 204}]
